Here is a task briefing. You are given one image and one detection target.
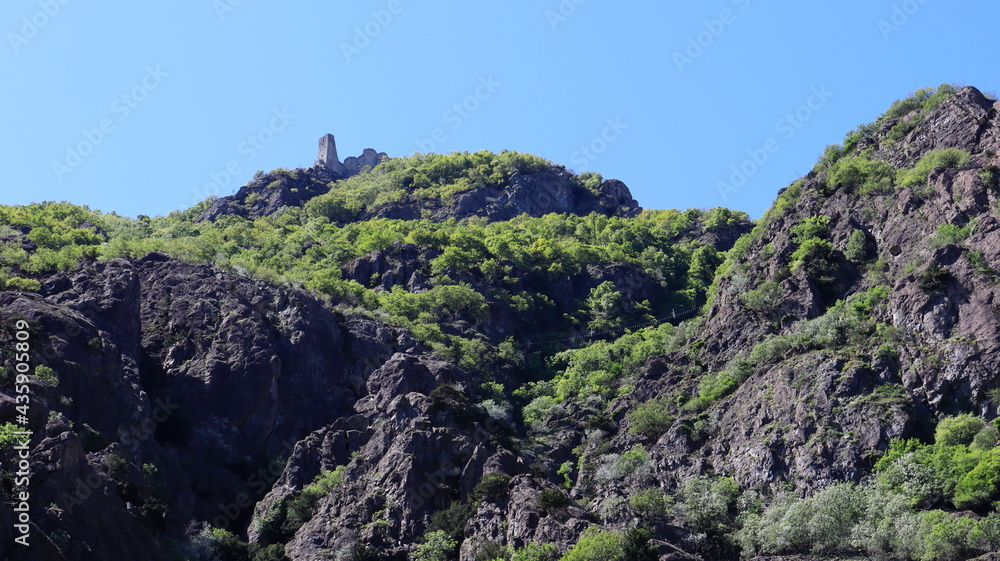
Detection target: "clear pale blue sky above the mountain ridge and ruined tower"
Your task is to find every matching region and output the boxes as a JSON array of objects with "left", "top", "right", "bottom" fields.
[{"left": 0, "top": 0, "right": 1000, "bottom": 217}]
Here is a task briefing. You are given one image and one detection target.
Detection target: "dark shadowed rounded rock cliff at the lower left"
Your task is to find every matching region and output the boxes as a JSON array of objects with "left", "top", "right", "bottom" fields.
[{"left": 0, "top": 254, "right": 363, "bottom": 560}]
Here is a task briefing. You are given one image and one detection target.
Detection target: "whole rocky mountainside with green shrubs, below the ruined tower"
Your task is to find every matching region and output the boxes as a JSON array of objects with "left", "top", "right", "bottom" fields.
[{"left": 0, "top": 86, "right": 1000, "bottom": 561}]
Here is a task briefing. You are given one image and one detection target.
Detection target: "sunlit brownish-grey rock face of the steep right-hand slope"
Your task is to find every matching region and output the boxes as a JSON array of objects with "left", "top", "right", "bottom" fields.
[{"left": 644, "top": 88, "right": 1000, "bottom": 488}]
